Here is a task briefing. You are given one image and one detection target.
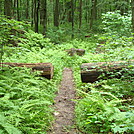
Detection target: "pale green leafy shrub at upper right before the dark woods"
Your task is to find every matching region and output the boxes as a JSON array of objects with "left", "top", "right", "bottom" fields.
[{"left": 102, "top": 11, "right": 132, "bottom": 36}]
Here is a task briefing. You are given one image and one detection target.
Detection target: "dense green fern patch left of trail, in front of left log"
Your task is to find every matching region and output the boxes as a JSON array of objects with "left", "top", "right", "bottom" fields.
[{"left": 0, "top": 68, "right": 56, "bottom": 134}]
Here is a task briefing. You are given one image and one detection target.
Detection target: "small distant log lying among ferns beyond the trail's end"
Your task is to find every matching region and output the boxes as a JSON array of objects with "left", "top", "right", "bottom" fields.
[{"left": 65, "top": 48, "right": 85, "bottom": 56}]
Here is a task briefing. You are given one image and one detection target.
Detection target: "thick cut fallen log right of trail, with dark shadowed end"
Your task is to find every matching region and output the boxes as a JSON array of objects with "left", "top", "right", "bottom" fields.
[{"left": 81, "top": 60, "right": 134, "bottom": 83}]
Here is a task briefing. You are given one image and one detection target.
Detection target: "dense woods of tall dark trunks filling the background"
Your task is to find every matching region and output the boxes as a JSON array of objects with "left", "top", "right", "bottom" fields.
[{"left": 0, "top": 0, "right": 134, "bottom": 36}]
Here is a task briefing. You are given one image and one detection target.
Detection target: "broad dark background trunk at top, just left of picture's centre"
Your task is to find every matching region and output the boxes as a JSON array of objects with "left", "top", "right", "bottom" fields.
[{"left": 54, "top": 0, "right": 59, "bottom": 27}]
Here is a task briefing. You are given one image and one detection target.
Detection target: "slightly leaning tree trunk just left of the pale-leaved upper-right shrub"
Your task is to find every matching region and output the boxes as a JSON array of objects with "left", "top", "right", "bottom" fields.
[{"left": 90, "top": 0, "right": 97, "bottom": 29}]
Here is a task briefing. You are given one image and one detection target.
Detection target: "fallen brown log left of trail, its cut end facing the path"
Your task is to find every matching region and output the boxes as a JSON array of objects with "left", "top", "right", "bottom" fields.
[{"left": 0, "top": 63, "right": 54, "bottom": 79}]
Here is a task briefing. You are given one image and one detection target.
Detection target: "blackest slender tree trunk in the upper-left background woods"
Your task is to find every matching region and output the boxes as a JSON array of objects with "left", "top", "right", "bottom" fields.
[{"left": 34, "top": 0, "right": 40, "bottom": 33}]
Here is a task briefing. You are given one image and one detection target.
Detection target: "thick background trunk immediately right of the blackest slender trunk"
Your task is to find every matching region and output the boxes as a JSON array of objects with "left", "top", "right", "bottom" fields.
[{"left": 40, "top": 0, "right": 47, "bottom": 35}]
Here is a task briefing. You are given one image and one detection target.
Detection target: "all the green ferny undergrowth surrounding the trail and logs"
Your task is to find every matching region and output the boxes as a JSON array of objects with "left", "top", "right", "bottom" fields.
[{"left": 0, "top": 14, "right": 134, "bottom": 134}]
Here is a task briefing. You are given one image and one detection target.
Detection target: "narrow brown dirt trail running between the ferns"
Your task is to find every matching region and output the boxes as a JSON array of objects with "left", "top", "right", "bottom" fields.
[{"left": 49, "top": 68, "right": 78, "bottom": 134}]
